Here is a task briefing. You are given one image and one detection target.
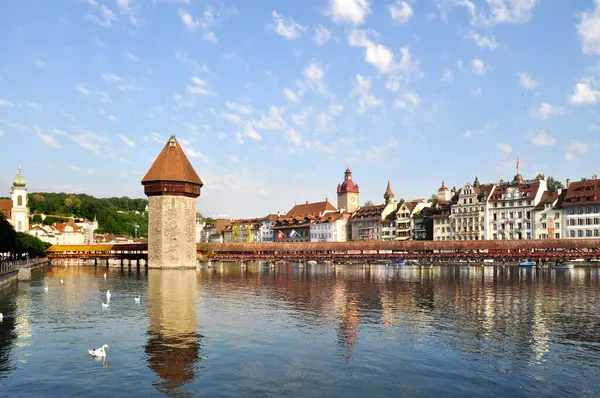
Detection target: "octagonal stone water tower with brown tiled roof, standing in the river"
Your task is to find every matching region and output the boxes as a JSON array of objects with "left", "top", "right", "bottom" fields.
[{"left": 142, "top": 135, "right": 204, "bottom": 268}]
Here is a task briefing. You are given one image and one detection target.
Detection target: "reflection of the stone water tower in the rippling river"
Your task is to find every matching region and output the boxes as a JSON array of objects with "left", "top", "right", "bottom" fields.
[{"left": 146, "top": 269, "right": 202, "bottom": 394}]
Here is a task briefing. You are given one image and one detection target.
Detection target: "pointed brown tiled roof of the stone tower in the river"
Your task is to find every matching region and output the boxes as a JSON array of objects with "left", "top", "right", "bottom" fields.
[{"left": 142, "top": 135, "right": 204, "bottom": 186}]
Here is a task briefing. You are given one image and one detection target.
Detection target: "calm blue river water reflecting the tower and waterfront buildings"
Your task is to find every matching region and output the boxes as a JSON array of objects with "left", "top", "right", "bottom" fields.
[{"left": 0, "top": 263, "right": 600, "bottom": 397}]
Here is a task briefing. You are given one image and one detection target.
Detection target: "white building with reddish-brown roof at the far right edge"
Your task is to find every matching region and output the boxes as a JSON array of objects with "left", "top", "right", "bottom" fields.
[{"left": 559, "top": 178, "right": 600, "bottom": 238}]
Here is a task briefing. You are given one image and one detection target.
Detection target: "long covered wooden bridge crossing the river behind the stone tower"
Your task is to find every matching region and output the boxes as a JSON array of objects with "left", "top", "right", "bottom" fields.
[{"left": 47, "top": 238, "right": 600, "bottom": 262}]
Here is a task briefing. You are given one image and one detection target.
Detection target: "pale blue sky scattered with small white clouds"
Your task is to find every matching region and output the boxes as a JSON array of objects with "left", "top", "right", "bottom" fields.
[{"left": 0, "top": 0, "right": 600, "bottom": 217}]
